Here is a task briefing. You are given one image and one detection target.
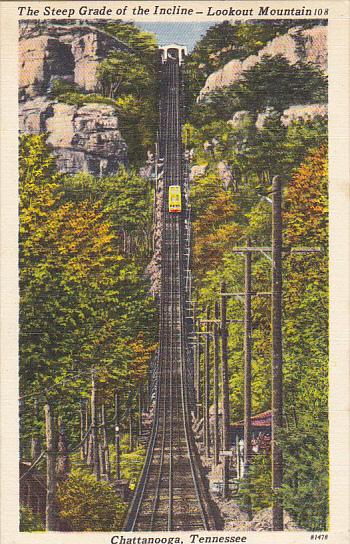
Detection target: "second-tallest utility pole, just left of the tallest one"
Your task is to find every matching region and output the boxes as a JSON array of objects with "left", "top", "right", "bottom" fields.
[{"left": 243, "top": 239, "right": 252, "bottom": 476}]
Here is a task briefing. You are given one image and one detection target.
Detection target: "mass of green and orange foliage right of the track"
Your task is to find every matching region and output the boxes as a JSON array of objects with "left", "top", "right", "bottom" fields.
[{"left": 187, "top": 23, "right": 328, "bottom": 530}]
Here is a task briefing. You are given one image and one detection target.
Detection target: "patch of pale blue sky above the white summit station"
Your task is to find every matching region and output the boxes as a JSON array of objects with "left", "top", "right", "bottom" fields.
[{"left": 136, "top": 22, "right": 212, "bottom": 52}]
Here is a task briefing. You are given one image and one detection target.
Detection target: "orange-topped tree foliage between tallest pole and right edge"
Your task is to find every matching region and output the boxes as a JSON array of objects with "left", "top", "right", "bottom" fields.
[{"left": 283, "top": 146, "right": 328, "bottom": 530}]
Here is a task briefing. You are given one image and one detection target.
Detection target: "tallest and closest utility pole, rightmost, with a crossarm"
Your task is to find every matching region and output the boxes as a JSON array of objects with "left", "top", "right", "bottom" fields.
[{"left": 271, "top": 176, "right": 283, "bottom": 531}]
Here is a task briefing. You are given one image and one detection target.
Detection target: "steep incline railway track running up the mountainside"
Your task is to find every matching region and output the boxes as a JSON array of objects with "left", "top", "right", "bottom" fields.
[{"left": 124, "top": 59, "right": 215, "bottom": 531}]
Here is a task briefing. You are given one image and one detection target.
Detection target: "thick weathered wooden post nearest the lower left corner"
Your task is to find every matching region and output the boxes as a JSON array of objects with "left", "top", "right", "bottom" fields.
[{"left": 45, "top": 403, "right": 57, "bottom": 531}]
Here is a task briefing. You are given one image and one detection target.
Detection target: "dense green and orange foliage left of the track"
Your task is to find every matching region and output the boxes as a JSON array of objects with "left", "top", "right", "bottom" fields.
[{"left": 20, "top": 135, "right": 157, "bottom": 456}]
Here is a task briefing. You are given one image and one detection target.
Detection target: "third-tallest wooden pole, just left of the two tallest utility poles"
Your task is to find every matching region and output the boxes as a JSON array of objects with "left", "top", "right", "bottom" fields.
[{"left": 221, "top": 282, "right": 230, "bottom": 498}]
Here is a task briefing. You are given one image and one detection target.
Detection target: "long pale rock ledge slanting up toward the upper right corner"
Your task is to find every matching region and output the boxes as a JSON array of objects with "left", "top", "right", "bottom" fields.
[{"left": 199, "top": 26, "right": 327, "bottom": 100}]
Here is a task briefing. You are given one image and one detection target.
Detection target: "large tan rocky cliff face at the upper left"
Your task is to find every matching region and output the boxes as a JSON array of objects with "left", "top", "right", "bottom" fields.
[{"left": 19, "top": 21, "right": 128, "bottom": 175}]
